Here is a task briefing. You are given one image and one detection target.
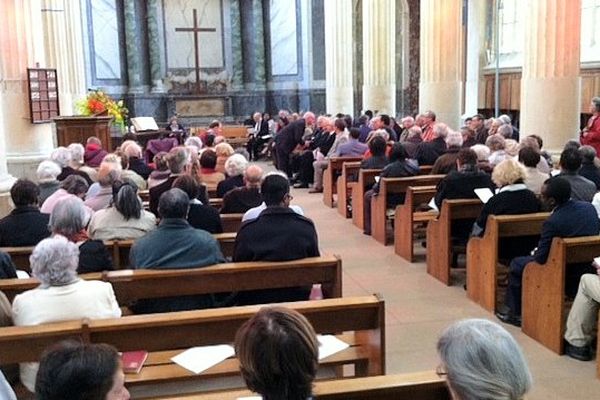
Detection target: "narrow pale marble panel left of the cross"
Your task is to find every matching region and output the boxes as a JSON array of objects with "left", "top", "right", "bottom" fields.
[{"left": 90, "top": 0, "right": 121, "bottom": 79}]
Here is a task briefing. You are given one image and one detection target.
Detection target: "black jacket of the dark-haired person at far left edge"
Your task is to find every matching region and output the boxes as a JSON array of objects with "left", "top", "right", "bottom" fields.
[{"left": 0, "top": 206, "right": 50, "bottom": 247}]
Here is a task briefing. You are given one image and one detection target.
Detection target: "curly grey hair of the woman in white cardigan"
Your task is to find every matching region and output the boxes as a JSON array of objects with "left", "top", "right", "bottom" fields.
[{"left": 29, "top": 235, "right": 79, "bottom": 286}]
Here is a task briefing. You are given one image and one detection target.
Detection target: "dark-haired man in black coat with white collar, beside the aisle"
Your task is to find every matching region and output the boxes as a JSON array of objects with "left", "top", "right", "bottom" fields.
[{"left": 233, "top": 174, "right": 319, "bottom": 304}]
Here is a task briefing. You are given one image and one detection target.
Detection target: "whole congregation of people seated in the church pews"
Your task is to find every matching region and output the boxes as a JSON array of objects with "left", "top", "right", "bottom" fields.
[{"left": 0, "top": 98, "right": 600, "bottom": 400}]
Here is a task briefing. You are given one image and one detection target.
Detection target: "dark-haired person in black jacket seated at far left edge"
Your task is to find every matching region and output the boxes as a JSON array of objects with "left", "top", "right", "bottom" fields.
[{"left": 0, "top": 179, "right": 50, "bottom": 247}]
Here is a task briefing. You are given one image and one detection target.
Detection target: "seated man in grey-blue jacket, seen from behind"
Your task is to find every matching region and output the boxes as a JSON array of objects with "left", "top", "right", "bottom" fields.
[{"left": 129, "top": 188, "right": 225, "bottom": 313}]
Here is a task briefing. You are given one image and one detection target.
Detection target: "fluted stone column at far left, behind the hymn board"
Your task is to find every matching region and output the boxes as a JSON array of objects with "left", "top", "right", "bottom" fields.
[{"left": 0, "top": 0, "right": 54, "bottom": 186}]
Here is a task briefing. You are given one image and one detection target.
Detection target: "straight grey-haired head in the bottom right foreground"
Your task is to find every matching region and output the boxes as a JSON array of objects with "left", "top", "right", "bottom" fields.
[{"left": 437, "top": 319, "right": 531, "bottom": 400}]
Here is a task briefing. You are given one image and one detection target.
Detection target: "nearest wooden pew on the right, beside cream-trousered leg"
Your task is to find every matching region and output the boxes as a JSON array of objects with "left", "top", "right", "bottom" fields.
[{"left": 522, "top": 235, "right": 600, "bottom": 354}]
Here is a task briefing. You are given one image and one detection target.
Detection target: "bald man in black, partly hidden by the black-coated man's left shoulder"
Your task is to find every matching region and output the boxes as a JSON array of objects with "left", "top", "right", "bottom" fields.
[{"left": 221, "top": 164, "right": 263, "bottom": 214}]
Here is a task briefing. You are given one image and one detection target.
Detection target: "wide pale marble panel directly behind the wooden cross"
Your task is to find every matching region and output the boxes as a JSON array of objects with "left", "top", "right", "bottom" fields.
[{"left": 164, "top": 0, "right": 224, "bottom": 69}]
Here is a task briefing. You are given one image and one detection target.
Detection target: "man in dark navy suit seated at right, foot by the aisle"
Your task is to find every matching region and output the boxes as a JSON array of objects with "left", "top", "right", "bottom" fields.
[{"left": 496, "top": 176, "right": 600, "bottom": 326}]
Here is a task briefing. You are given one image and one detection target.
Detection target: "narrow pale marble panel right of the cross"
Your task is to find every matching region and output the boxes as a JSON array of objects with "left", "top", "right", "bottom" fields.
[{"left": 269, "top": 0, "right": 298, "bottom": 76}]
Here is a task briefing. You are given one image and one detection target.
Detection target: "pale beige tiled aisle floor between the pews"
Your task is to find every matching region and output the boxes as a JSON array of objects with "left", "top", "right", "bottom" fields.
[{"left": 293, "top": 184, "right": 600, "bottom": 400}]
